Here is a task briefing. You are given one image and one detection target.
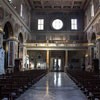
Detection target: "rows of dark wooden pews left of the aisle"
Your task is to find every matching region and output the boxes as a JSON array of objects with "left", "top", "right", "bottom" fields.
[{"left": 0, "top": 69, "right": 47, "bottom": 100}]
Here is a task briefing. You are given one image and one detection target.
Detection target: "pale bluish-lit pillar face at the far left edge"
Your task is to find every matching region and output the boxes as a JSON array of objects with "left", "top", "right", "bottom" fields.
[{"left": 0, "top": 48, "right": 5, "bottom": 75}]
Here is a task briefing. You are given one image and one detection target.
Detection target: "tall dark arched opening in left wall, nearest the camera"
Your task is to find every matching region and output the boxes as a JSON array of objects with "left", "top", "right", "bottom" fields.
[{"left": 3, "top": 22, "right": 13, "bottom": 70}]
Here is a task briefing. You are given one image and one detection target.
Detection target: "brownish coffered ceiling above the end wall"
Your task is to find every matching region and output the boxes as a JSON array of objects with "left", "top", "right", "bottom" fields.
[{"left": 29, "top": 0, "right": 87, "bottom": 11}]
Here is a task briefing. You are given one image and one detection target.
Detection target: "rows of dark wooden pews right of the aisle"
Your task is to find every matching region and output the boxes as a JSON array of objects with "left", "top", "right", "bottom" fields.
[{"left": 67, "top": 69, "right": 100, "bottom": 100}]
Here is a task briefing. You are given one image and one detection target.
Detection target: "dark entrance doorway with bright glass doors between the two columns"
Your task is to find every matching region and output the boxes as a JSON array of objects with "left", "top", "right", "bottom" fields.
[{"left": 50, "top": 50, "right": 65, "bottom": 72}]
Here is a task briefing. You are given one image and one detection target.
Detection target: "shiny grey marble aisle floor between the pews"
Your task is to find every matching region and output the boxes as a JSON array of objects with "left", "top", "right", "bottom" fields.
[{"left": 17, "top": 72, "right": 87, "bottom": 100}]
